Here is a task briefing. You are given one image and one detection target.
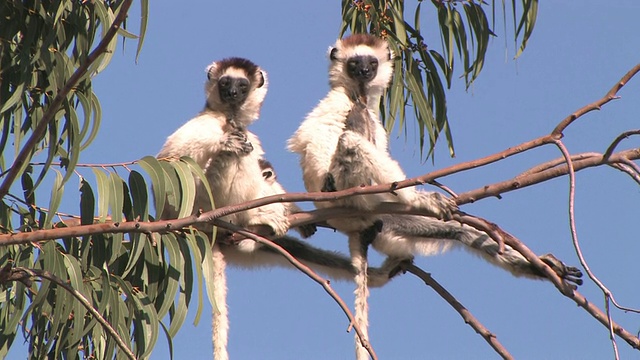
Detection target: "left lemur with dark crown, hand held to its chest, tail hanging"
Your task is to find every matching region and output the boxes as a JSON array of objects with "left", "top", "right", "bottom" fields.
[{"left": 157, "top": 58, "right": 398, "bottom": 360}]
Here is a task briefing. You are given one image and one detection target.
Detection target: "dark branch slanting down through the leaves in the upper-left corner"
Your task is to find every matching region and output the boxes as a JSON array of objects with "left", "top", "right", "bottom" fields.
[{"left": 0, "top": 0, "right": 132, "bottom": 198}]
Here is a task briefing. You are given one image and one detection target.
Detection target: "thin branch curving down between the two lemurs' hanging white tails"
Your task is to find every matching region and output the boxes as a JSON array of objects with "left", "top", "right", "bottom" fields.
[{"left": 213, "top": 220, "right": 378, "bottom": 360}]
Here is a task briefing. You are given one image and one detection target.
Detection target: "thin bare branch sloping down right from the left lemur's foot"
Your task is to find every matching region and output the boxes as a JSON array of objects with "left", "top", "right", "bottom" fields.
[{"left": 401, "top": 264, "right": 513, "bottom": 359}]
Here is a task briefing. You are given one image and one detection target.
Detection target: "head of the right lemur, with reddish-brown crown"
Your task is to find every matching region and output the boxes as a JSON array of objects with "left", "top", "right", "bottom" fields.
[{"left": 329, "top": 34, "right": 393, "bottom": 95}]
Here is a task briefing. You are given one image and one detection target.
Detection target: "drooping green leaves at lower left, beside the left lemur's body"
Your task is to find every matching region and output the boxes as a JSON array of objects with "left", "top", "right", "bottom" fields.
[{"left": 0, "top": 156, "right": 218, "bottom": 359}]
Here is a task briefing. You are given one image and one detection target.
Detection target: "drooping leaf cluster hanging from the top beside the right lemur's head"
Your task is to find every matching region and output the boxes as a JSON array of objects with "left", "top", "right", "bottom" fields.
[{"left": 340, "top": 0, "right": 538, "bottom": 157}]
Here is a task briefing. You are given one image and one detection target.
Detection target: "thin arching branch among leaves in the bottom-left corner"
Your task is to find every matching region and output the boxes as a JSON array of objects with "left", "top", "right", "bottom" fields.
[{"left": 0, "top": 267, "right": 136, "bottom": 360}]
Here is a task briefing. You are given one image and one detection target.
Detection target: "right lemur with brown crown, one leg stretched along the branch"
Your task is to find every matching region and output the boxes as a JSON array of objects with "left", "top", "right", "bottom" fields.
[{"left": 288, "top": 34, "right": 580, "bottom": 359}]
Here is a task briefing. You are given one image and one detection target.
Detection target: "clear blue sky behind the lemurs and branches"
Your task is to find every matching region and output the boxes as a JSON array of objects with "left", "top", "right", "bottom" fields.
[{"left": 12, "top": 0, "right": 640, "bottom": 359}]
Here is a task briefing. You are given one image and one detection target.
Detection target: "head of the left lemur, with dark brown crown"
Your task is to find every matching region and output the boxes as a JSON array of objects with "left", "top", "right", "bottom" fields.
[{"left": 205, "top": 57, "right": 268, "bottom": 125}]
